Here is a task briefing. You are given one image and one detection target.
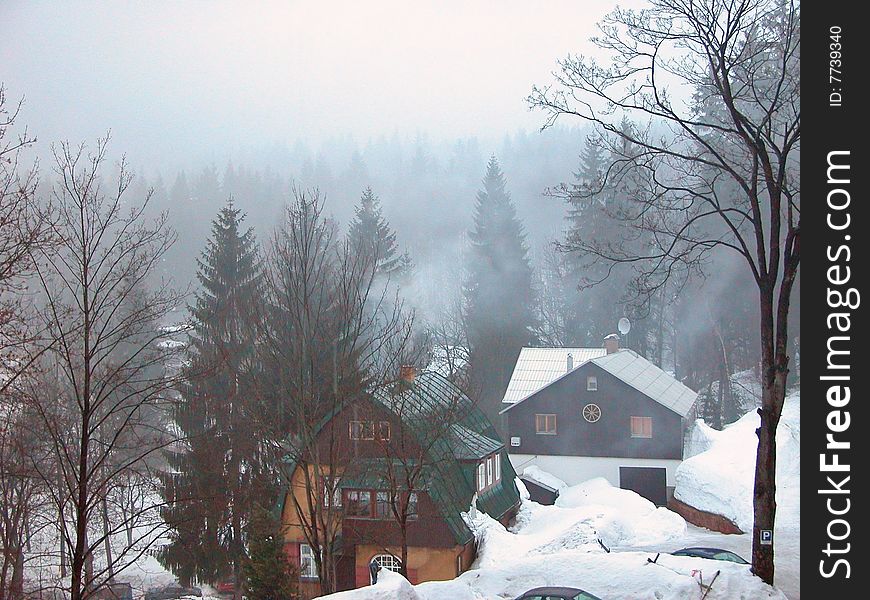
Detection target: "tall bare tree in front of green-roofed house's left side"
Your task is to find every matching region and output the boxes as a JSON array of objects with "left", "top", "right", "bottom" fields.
[{"left": 255, "top": 191, "right": 413, "bottom": 594}]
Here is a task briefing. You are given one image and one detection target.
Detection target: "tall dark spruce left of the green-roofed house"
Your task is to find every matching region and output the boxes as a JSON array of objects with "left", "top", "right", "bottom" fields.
[{"left": 161, "top": 201, "right": 271, "bottom": 589}]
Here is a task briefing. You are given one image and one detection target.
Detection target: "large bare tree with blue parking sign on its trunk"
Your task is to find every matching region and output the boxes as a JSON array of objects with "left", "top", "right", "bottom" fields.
[{"left": 529, "top": 0, "right": 800, "bottom": 583}]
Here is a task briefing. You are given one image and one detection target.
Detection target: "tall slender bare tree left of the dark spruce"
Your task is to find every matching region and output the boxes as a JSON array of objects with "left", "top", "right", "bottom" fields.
[{"left": 31, "top": 139, "right": 180, "bottom": 600}]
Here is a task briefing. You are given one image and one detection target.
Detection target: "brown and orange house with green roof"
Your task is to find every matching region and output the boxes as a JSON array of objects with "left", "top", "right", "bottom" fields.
[{"left": 281, "top": 368, "right": 520, "bottom": 597}]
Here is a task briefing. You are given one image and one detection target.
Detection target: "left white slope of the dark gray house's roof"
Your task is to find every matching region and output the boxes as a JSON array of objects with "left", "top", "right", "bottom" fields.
[{"left": 502, "top": 348, "right": 606, "bottom": 404}]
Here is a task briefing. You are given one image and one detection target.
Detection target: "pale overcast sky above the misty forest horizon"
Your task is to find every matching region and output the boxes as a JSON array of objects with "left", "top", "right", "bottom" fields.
[{"left": 0, "top": 0, "right": 640, "bottom": 169}]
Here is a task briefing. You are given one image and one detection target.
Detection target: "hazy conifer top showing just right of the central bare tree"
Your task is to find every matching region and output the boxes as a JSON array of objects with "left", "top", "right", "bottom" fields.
[{"left": 348, "top": 187, "right": 412, "bottom": 278}]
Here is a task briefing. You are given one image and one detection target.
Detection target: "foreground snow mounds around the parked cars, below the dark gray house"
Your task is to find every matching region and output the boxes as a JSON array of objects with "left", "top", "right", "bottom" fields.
[{"left": 318, "top": 479, "right": 786, "bottom": 600}]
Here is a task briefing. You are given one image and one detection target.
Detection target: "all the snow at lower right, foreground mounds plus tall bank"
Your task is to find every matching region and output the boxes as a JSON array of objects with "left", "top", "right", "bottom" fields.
[{"left": 316, "top": 394, "right": 800, "bottom": 600}]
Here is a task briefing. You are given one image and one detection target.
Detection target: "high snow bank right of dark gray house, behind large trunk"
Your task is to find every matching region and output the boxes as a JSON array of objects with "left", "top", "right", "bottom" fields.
[{"left": 674, "top": 394, "right": 800, "bottom": 531}]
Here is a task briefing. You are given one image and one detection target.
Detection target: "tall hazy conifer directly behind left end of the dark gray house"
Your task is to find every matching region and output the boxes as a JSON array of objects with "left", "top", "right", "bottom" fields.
[{"left": 463, "top": 156, "right": 536, "bottom": 421}]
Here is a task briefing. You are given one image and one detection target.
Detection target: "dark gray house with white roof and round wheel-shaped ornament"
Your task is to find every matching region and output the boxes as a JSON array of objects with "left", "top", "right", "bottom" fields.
[{"left": 501, "top": 335, "right": 697, "bottom": 505}]
